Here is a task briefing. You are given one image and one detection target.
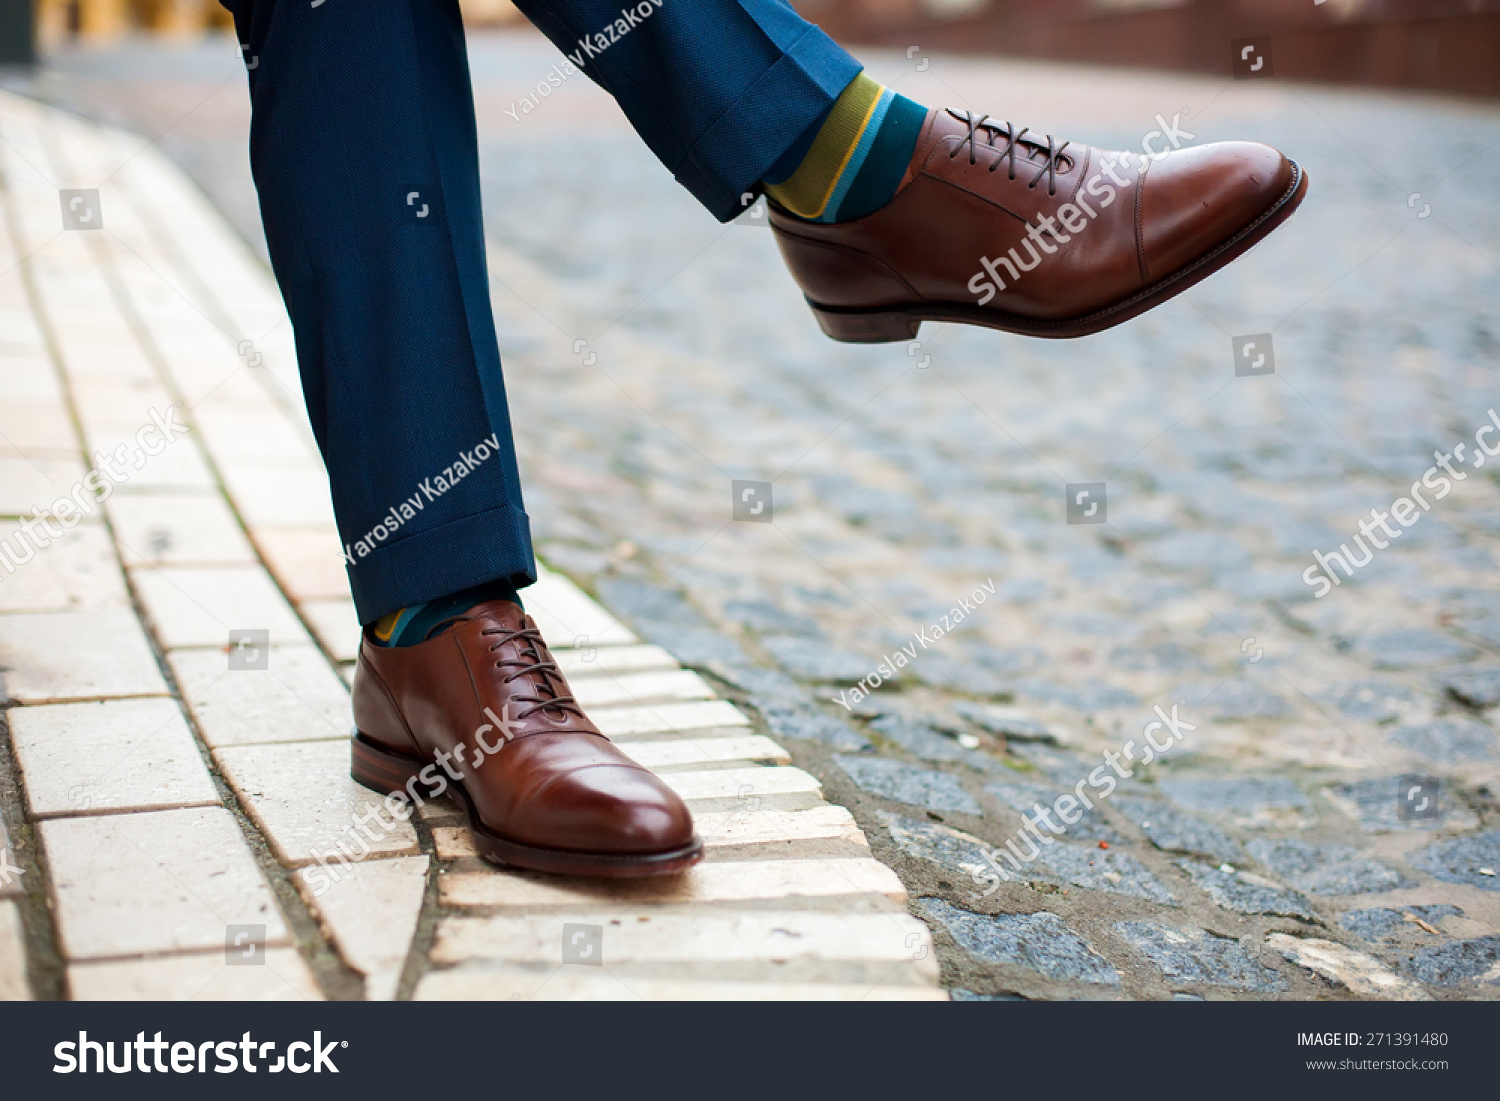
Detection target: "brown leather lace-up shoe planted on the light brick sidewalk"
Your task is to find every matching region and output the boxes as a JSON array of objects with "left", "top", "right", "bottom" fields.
[{"left": 353, "top": 600, "right": 704, "bottom": 878}]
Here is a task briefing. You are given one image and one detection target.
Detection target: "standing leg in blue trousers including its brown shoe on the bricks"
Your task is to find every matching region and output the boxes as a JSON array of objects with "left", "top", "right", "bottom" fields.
[{"left": 227, "top": 0, "right": 704, "bottom": 876}]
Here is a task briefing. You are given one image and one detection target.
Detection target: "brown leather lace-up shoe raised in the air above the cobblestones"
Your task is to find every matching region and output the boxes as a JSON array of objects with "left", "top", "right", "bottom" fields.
[{"left": 770, "top": 110, "right": 1308, "bottom": 344}]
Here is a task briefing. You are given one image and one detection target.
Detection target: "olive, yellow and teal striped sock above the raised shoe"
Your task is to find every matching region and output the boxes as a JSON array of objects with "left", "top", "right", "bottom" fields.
[{"left": 762, "top": 74, "right": 927, "bottom": 222}]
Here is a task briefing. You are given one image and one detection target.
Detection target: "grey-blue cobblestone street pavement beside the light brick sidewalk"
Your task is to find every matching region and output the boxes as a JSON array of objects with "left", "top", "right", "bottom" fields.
[{"left": 8, "top": 36, "right": 1500, "bottom": 999}]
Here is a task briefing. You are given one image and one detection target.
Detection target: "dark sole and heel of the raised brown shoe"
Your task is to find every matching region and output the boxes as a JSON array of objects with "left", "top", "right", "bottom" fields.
[{"left": 807, "top": 161, "right": 1308, "bottom": 344}]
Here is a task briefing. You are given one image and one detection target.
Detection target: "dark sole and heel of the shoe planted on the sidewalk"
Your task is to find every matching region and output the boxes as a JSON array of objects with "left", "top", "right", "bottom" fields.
[{"left": 350, "top": 732, "right": 704, "bottom": 879}]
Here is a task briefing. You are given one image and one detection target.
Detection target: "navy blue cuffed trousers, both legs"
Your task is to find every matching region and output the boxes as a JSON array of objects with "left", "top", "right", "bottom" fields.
[{"left": 222, "top": 0, "right": 861, "bottom": 623}]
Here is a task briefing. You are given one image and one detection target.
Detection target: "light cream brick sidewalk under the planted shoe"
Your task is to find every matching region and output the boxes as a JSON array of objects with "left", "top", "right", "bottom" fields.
[{"left": 0, "top": 96, "right": 944, "bottom": 999}]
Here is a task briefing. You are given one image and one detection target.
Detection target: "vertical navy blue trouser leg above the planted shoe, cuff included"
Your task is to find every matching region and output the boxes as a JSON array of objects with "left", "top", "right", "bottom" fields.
[{"left": 227, "top": 0, "right": 536, "bottom": 623}]
